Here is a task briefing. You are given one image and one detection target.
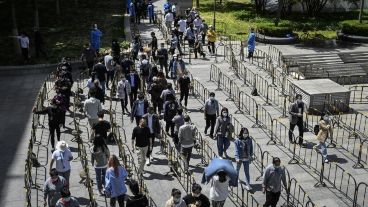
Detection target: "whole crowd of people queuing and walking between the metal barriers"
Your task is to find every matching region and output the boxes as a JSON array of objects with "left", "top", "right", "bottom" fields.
[{"left": 33, "top": 0, "right": 331, "bottom": 207}]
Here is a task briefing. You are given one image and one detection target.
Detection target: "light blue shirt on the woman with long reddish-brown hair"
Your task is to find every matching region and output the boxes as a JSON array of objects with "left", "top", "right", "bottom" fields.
[{"left": 105, "top": 166, "right": 128, "bottom": 198}]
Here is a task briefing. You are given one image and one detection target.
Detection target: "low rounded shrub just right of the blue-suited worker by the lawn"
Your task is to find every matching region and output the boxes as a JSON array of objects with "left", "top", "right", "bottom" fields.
[{"left": 257, "top": 23, "right": 293, "bottom": 37}]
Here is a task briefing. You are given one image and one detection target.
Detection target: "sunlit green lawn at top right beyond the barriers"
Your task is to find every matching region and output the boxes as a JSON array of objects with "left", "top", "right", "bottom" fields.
[{"left": 197, "top": 0, "right": 368, "bottom": 39}]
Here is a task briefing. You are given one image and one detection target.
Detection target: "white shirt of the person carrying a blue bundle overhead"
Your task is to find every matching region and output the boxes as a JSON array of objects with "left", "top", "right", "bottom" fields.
[{"left": 210, "top": 175, "right": 230, "bottom": 201}]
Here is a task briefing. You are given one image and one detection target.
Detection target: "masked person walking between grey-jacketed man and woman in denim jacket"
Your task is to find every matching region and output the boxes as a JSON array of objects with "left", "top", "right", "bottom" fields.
[{"left": 215, "top": 107, "right": 234, "bottom": 158}]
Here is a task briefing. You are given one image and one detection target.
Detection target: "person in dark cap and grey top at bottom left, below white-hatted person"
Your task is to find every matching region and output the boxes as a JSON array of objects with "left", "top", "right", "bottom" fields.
[{"left": 43, "top": 168, "right": 67, "bottom": 207}]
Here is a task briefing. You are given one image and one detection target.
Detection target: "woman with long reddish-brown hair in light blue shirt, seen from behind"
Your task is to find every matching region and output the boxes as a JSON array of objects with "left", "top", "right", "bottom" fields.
[{"left": 105, "top": 155, "right": 128, "bottom": 207}]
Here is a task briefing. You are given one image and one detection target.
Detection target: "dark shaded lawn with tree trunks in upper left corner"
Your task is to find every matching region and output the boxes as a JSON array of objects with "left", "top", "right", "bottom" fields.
[{"left": 0, "top": 0, "right": 124, "bottom": 65}]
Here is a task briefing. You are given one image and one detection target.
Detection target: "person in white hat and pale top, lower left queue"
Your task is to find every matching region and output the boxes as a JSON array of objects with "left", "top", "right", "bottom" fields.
[{"left": 50, "top": 141, "right": 73, "bottom": 183}]
